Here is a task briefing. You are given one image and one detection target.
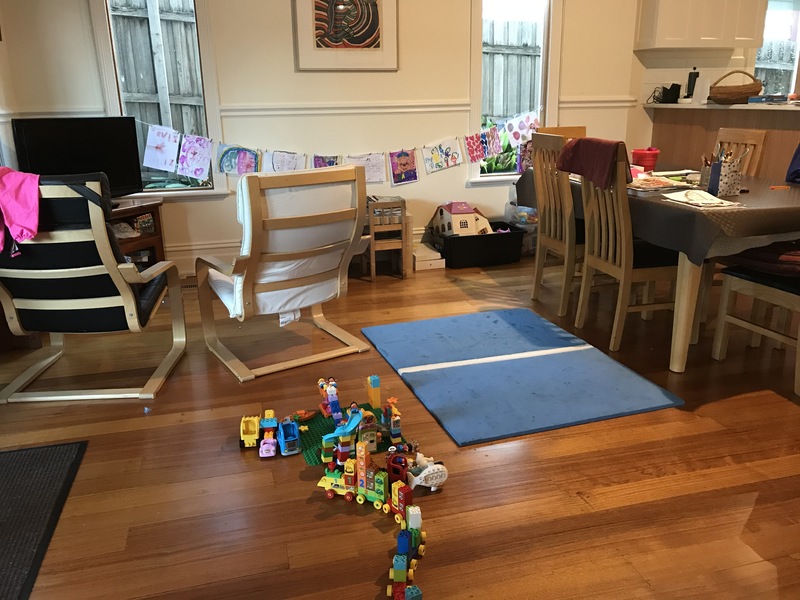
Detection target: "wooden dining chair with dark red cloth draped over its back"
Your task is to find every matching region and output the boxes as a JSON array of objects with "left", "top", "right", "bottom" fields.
[{"left": 558, "top": 138, "right": 678, "bottom": 351}]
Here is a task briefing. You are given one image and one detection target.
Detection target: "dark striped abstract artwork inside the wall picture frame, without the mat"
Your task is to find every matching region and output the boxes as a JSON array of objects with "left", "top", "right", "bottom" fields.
[{"left": 314, "top": 0, "right": 381, "bottom": 49}]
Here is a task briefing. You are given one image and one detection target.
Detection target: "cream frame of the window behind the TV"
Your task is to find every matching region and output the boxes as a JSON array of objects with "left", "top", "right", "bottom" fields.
[{"left": 89, "top": 0, "right": 231, "bottom": 198}]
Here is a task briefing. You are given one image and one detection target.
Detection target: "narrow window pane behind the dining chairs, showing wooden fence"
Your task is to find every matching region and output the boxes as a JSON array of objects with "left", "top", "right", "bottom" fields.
[{"left": 480, "top": 0, "right": 549, "bottom": 175}]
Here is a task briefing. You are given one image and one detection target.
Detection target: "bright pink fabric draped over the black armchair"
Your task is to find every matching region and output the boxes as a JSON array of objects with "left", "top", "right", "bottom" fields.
[{"left": 0, "top": 167, "right": 39, "bottom": 251}]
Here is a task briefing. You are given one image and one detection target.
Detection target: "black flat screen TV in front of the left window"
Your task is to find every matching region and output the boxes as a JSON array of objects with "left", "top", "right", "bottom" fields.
[{"left": 11, "top": 117, "right": 142, "bottom": 198}]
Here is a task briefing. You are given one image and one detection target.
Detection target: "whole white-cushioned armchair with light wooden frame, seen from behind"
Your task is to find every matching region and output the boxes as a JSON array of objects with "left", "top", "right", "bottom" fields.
[{"left": 195, "top": 165, "right": 369, "bottom": 382}]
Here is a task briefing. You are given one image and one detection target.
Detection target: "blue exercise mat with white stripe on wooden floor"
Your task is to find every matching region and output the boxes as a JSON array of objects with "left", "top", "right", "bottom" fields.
[{"left": 362, "top": 309, "right": 683, "bottom": 446}]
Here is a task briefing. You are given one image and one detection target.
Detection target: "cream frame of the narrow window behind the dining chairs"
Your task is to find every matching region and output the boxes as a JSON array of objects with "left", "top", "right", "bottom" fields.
[{"left": 467, "top": 0, "right": 565, "bottom": 187}]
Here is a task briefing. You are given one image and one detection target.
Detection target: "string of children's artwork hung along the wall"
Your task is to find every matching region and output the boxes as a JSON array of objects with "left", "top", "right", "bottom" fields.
[{"left": 142, "top": 112, "right": 539, "bottom": 185}]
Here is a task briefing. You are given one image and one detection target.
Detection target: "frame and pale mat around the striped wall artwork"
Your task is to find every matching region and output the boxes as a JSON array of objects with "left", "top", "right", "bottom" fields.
[{"left": 292, "top": 0, "right": 398, "bottom": 71}]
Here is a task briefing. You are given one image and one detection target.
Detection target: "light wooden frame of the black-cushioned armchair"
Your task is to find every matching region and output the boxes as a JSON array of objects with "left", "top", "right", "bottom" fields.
[{"left": 0, "top": 174, "right": 186, "bottom": 404}]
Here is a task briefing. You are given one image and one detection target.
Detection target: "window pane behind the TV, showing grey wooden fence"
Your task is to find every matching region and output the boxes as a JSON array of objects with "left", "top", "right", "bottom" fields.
[{"left": 92, "top": 0, "right": 219, "bottom": 190}]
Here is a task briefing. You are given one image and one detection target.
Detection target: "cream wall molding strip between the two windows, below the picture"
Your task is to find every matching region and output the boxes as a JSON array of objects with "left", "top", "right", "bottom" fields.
[{"left": 219, "top": 98, "right": 470, "bottom": 119}]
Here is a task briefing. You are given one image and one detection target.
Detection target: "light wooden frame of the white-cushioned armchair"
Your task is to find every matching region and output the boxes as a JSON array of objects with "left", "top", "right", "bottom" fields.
[{"left": 196, "top": 165, "right": 369, "bottom": 382}]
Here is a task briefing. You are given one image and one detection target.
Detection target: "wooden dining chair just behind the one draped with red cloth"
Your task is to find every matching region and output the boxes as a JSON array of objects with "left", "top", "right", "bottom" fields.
[{"left": 531, "top": 133, "right": 585, "bottom": 317}]
